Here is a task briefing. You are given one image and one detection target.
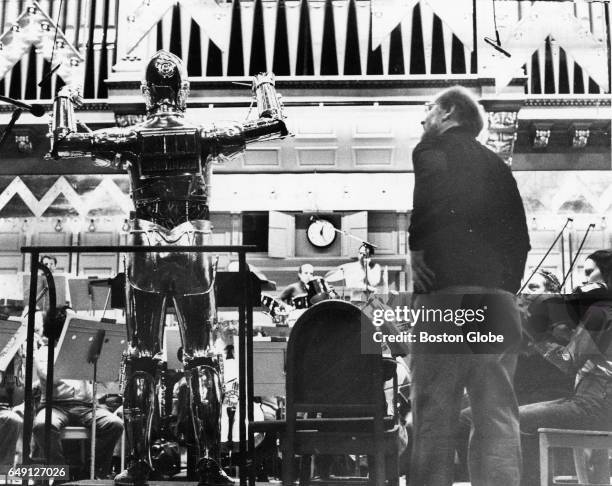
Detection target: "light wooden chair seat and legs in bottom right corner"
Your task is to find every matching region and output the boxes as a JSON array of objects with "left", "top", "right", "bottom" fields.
[{"left": 538, "top": 429, "right": 612, "bottom": 486}]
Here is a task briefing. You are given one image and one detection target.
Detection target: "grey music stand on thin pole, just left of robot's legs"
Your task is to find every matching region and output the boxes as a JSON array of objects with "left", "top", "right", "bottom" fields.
[{"left": 54, "top": 316, "right": 127, "bottom": 480}]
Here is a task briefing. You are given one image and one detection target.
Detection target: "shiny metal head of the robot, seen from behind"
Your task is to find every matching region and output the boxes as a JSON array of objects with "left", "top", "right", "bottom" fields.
[{"left": 141, "top": 50, "right": 189, "bottom": 113}]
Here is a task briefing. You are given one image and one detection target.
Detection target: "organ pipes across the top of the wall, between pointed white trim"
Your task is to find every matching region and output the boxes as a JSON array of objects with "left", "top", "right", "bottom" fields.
[{"left": 0, "top": 0, "right": 609, "bottom": 100}]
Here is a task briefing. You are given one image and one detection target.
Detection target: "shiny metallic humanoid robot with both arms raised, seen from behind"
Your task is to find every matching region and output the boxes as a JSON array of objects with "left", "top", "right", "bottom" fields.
[{"left": 51, "top": 51, "right": 287, "bottom": 485}]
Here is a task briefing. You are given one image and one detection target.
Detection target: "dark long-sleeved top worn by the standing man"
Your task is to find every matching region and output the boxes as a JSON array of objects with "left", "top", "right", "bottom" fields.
[{"left": 409, "top": 127, "right": 530, "bottom": 292}]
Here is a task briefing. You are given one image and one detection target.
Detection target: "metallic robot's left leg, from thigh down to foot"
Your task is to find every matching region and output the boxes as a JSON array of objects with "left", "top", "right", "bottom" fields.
[{"left": 115, "top": 280, "right": 165, "bottom": 486}]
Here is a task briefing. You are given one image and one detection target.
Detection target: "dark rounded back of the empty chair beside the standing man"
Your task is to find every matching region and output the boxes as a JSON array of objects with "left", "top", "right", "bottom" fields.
[{"left": 286, "top": 300, "right": 385, "bottom": 419}]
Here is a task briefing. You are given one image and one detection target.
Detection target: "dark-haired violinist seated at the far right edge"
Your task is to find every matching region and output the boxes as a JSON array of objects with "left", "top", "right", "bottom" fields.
[{"left": 519, "top": 250, "right": 612, "bottom": 486}]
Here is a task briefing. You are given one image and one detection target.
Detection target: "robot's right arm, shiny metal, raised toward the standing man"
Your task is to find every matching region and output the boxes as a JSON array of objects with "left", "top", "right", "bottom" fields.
[{"left": 203, "top": 73, "right": 289, "bottom": 159}]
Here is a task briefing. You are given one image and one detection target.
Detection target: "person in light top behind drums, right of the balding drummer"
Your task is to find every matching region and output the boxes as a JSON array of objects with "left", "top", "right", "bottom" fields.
[{"left": 325, "top": 243, "right": 382, "bottom": 302}]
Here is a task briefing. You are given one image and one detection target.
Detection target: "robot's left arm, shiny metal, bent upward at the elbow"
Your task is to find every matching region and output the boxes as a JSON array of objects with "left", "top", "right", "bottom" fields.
[{"left": 49, "top": 87, "right": 136, "bottom": 165}]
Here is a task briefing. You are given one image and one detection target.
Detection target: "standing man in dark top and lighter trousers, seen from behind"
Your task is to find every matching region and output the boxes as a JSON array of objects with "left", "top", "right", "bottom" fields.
[{"left": 409, "top": 87, "right": 530, "bottom": 486}]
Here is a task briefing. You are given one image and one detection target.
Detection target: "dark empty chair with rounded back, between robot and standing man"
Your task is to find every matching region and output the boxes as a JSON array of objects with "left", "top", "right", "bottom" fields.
[{"left": 281, "top": 300, "right": 399, "bottom": 486}]
